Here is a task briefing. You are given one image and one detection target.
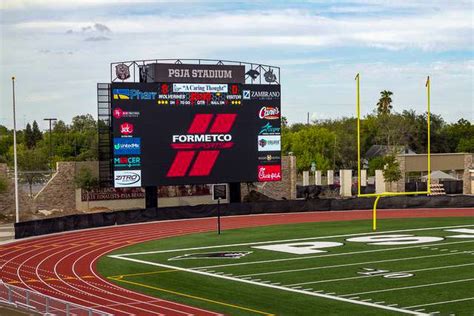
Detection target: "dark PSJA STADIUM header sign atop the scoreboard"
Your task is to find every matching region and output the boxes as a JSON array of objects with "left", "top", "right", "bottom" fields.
[{"left": 154, "top": 63, "right": 245, "bottom": 84}]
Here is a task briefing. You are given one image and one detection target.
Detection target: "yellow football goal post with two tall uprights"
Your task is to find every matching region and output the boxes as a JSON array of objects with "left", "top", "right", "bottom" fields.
[{"left": 355, "top": 73, "right": 431, "bottom": 231}]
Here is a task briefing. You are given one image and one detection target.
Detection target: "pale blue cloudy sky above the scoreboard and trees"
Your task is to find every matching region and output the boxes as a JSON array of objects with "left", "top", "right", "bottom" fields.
[{"left": 0, "top": 0, "right": 474, "bottom": 129}]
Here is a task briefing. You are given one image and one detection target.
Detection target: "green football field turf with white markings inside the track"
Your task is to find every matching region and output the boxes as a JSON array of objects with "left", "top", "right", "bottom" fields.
[{"left": 98, "top": 217, "right": 474, "bottom": 315}]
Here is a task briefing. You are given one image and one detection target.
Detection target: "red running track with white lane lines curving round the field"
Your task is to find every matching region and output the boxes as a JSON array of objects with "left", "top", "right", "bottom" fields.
[{"left": 0, "top": 209, "right": 474, "bottom": 315}]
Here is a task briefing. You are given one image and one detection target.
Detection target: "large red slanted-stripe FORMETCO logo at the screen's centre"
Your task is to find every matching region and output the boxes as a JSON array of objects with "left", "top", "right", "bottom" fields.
[{"left": 166, "top": 114, "right": 237, "bottom": 177}]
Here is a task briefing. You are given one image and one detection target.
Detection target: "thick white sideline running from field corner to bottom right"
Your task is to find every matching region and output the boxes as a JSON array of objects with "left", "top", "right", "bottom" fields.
[{"left": 110, "top": 255, "right": 428, "bottom": 316}]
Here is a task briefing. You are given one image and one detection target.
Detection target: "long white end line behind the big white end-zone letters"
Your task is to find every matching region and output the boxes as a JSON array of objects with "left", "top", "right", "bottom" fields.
[{"left": 114, "top": 225, "right": 474, "bottom": 257}]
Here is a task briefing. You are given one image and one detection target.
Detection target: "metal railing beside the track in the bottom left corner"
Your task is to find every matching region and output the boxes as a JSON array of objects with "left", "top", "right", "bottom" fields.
[{"left": 0, "top": 280, "right": 112, "bottom": 316}]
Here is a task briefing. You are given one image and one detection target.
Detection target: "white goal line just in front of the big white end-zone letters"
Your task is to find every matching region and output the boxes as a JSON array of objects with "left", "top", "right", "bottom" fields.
[{"left": 187, "top": 240, "right": 474, "bottom": 269}]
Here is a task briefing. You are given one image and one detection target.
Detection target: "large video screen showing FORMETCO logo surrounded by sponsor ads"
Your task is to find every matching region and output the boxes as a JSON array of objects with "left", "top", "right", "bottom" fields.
[{"left": 111, "top": 83, "right": 281, "bottom": 187}]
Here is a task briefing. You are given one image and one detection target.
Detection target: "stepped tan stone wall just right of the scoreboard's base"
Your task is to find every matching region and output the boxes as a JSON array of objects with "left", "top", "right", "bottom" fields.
[{"left": 241, "top": 156, "right": 296, "bottom": 200}]
